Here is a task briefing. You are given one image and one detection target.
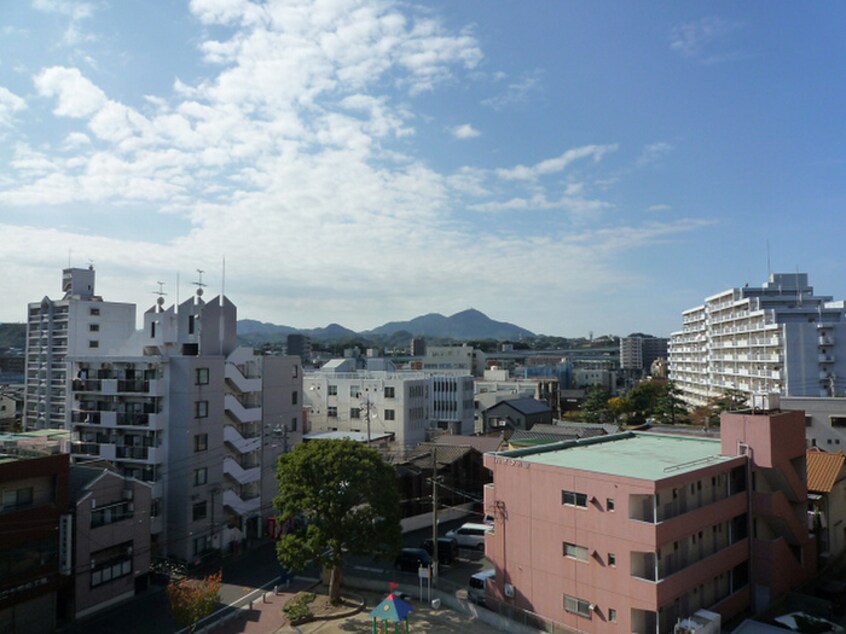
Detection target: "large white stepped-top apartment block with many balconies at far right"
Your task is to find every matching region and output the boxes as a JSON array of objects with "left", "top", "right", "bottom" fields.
[{"left": 669, "top": 273, "right": 846, "bottom": 405}]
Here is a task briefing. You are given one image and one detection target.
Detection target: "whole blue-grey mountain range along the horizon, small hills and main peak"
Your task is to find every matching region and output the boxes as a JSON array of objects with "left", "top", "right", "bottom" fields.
[{"left": 238, "top": 308, "right": 535, "bottom": 341}]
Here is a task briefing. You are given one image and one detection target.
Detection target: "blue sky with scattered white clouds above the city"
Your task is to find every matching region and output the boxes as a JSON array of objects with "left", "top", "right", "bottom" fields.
[{"left": 0, "top": 0, "right": 846, "bottom": 337}]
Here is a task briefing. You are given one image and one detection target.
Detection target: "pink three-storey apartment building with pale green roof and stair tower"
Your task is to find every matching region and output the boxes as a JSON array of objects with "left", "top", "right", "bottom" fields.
[{"left": 485, "top": 411, "right": 815, "bottom": 633}]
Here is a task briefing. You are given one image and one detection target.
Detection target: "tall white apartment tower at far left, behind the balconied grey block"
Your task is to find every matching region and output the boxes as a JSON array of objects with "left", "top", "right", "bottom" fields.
[{"left": 23, "top": 267, "right": 135, "bottom": 430}]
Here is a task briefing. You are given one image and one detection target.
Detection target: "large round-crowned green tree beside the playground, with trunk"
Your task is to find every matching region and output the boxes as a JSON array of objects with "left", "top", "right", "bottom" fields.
[{"left": 273, "top": 440, "right": 402, "bottom": 603}]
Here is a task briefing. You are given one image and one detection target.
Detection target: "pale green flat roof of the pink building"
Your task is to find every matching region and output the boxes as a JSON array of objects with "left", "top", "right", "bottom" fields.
[{"left": 498, "top": 432, "right": 736, "bottom": 481}]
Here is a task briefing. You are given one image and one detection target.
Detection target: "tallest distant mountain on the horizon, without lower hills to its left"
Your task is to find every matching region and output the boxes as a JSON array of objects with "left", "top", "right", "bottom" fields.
[{"left": 362, "top": 308, "right": 535, "bottom": 341}]
